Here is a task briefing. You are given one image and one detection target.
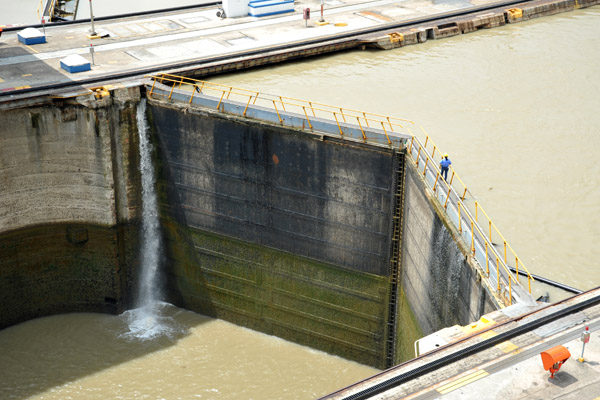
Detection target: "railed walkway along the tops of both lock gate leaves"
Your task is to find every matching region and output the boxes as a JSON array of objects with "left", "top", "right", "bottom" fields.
[{"left": 147, "top": 74, "right": 533, "bottom": 305}]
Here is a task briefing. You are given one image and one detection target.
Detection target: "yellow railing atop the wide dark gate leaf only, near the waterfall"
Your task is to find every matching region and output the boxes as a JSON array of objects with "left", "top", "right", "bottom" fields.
[{"left": 150, "top": 74, "right": 414, "bottom": 145}]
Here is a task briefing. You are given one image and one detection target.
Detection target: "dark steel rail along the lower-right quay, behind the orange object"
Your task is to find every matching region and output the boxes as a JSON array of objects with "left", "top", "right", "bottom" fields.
[{"left": 321, "top": 288, "right": 600, "bottom": 400}]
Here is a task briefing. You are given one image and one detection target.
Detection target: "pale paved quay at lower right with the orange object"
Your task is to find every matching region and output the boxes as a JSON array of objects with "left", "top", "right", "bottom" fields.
[{"left": 323, "top": 289, "right": 600, "bottom": 400}]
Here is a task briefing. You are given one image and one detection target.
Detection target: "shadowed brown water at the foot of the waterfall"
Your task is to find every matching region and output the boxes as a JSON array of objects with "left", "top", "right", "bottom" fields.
[{"left": 0, "top": 303, "right": 213, "bottom": 399}]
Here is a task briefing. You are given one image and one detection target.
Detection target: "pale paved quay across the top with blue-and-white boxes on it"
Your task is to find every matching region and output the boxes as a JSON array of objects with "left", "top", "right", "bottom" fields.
[{"left": 0, "top": 0, "right": 510, "bottom": 94}]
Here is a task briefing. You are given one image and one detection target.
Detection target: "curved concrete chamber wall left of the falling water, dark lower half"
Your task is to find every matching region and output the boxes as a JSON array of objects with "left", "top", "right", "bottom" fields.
[{"left": 0, "top": 87, "right": 140, "bottom": 327}]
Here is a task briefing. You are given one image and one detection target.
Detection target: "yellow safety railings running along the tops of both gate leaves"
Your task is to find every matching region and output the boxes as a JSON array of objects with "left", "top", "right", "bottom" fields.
[{"left": 148, "top": 74, "right": 534, "bottom": 304}]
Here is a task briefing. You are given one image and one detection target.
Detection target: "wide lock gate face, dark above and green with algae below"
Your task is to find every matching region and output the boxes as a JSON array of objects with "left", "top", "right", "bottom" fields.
[{"left": 149, "top": 100, "right": 396, "bottom": 367}]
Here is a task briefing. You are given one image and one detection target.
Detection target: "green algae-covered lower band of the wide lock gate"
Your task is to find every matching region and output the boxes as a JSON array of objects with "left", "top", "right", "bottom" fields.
[{"left": 163, "top": 221, "right": 389, "bottom": 368}]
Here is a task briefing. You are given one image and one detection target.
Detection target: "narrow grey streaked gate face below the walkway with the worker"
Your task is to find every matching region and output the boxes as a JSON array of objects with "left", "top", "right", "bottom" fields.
[{"left": 402, "top": 159, "right": 500, "bottom": 335}]
